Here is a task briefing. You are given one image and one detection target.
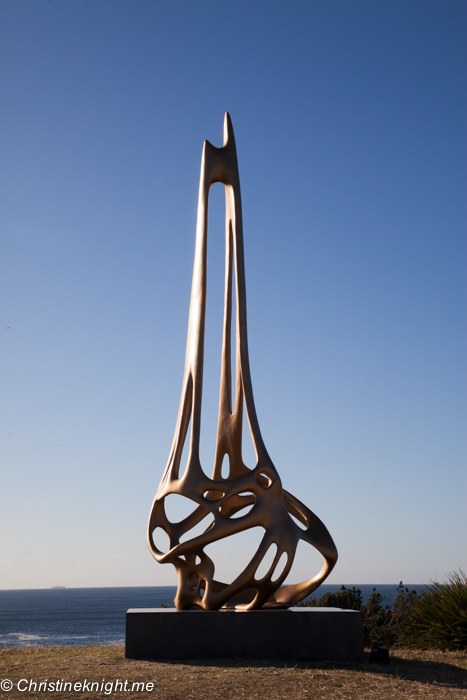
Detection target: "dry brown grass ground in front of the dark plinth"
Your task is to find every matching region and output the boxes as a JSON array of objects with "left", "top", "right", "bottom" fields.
[{"left": 0, "top": 647, "right": 467, "bottom": 700}]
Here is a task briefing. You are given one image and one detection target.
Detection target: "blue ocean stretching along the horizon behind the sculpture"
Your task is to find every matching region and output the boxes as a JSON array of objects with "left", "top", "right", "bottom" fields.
[{"left": 0, "top": 584, "right": 419, "bottom": 647}]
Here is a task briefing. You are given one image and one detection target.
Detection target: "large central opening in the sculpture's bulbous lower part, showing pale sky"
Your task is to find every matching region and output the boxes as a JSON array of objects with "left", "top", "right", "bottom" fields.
[{"left": 203, "top": 525, "right": 265, "bottom": 583}]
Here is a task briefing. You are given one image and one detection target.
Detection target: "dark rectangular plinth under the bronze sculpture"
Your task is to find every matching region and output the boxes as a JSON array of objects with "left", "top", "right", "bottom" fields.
[{"left": 125, "top": 608, "right": 363, "bottom": 661}]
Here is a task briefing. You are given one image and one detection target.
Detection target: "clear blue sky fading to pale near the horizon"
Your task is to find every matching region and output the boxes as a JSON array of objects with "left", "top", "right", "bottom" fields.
[{"left": 0, "top": 0, "right": 467, "bottom": 588}]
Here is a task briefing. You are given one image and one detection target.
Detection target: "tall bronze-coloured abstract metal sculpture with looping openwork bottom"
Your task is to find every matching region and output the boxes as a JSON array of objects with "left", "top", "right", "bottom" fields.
[{"left": 148, "top": 114, "right": 337, "bottom": 610}]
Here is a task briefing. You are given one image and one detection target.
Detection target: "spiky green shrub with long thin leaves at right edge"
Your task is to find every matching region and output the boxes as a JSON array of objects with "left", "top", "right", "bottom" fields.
[{"left": 401, "top": 570, "right": 467, "bottom": 651}]
